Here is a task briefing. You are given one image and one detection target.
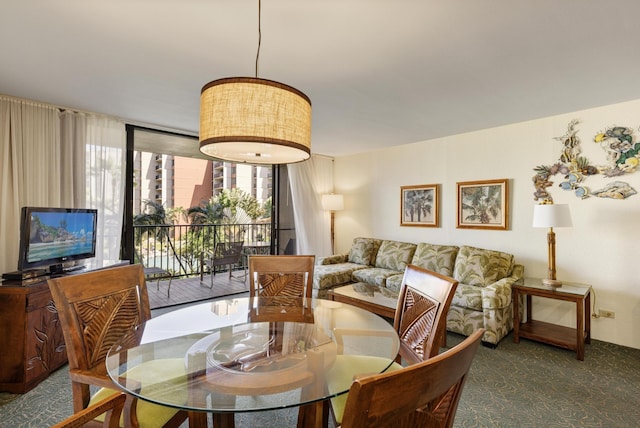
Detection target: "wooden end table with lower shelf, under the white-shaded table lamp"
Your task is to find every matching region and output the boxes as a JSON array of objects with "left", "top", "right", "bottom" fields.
[{"left": 511, "top": 278, "right": 591, "bottom": 361}]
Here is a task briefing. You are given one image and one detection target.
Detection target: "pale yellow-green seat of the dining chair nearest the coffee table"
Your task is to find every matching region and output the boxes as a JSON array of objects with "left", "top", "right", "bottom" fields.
[{"left": 327, "top": 355, "right": 402, "bottom": 425}]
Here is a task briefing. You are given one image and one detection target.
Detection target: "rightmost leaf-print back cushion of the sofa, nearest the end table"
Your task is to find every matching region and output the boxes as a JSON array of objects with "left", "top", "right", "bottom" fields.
[{"left": 453, "top": 245, "right": 513, "bottom": 287}]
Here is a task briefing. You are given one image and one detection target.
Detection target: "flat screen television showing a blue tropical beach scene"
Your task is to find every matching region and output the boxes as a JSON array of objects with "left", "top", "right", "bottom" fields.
[{"left": 18, "top": 207, "right": 98, "bottom": 274}]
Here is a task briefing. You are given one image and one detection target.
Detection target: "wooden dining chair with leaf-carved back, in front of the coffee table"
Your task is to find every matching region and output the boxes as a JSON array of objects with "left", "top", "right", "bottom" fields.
[{"left": 328, "top": 265, "right": 458, "bottom": 425}]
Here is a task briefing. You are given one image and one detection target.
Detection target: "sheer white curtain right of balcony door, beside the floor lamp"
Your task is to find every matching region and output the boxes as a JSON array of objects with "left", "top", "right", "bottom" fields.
[{"left": 287, "top": 155, "right": 333, "bottom": 257}]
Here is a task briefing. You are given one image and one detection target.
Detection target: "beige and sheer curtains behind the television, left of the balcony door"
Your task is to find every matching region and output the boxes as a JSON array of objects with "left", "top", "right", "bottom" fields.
[{"left": 0, "top": 96, "right": 126, "bottom": 272}]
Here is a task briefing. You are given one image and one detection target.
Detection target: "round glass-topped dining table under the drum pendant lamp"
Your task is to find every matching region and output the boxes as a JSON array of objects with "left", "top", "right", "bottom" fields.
[{"left": 106, "top": 297, "right": 399, "bottom": 427}]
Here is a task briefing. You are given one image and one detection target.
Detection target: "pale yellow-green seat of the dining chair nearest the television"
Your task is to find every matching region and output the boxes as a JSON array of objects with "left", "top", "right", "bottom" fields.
[{"left": 89, "top": 358, "right": 187, "bottom": 428}]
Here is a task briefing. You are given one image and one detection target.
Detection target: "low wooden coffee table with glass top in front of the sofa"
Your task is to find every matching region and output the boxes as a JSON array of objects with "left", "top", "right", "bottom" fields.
[{"left": 328, "top": 282, "right": 398, "bottom": 318}]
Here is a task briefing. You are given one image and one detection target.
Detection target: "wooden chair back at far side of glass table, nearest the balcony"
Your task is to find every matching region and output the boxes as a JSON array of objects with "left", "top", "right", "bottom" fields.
[{"left": 249, "top": 255, "right": 315, "bottom": 299}]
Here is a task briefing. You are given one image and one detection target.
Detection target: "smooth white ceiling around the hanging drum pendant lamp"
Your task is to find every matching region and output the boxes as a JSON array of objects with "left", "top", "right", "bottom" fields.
[{"left": 0, "top": 0, "right": 640, "bottom": 156}]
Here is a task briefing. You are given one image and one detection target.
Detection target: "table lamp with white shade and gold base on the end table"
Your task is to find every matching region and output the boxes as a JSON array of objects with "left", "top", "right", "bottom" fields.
[{"left": 533, "top": 203, "right": 571, "bottom": 288}]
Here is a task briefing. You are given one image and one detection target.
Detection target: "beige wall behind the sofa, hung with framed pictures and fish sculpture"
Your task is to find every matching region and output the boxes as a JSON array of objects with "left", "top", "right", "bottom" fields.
[{"left": 335, "top": 100, "right": 640, "bottom": 350}]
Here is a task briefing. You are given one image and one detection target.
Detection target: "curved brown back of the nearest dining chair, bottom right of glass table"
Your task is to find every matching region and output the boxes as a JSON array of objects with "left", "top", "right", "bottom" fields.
[{"left": 341, "top": 329, "right": 484, "bottom": 428}]
